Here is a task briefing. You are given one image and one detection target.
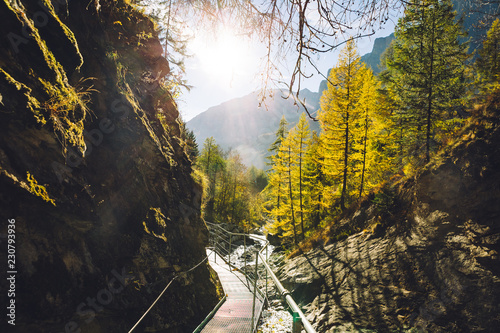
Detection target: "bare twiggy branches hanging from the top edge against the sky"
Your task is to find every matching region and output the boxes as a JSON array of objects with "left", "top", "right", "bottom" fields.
[{"left": 137, "top": 0, "right": 406, "bottom": 119}]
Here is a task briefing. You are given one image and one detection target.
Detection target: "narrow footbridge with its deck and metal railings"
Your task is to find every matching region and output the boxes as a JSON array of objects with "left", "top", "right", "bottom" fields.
[{"left": 193, "top": 222, "right": 316, "bottom": 333}]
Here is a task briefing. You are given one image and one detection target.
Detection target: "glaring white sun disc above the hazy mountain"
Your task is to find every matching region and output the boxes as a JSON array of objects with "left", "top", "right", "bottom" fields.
[{"left": 191, "top": 27, "right": 259, "bottom": 86}]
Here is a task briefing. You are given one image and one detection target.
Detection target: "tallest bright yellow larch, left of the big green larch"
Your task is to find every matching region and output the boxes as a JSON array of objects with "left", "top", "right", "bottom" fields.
[{"left": 319, "top": 39, "right": 366, "bottom": 210}]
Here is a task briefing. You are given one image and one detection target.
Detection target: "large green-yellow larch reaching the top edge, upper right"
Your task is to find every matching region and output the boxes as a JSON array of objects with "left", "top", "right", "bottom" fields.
[{"left": 387, "top": 0, "right": 468, "bottom": 162}]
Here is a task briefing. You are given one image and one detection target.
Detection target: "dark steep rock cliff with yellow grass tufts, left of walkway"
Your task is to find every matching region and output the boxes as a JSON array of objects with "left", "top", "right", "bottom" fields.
[{"left": 0, "top": 0, "right": 218, "bottom": 332}]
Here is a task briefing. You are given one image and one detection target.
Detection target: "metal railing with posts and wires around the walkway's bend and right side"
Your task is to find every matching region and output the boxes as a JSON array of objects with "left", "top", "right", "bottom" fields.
[{"left": 206, "top": 222, "right": 316, "bottom": 333}]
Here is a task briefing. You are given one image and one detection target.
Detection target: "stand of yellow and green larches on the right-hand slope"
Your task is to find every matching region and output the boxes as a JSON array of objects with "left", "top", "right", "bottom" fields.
[{"left": 264, "top": 0, "right": 498, "bottom": 247}]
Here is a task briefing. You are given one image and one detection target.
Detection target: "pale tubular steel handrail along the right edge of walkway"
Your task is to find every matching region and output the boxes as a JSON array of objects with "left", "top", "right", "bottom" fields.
[{"left": 205, "top": 222, "right": 316, "bottom": 333}]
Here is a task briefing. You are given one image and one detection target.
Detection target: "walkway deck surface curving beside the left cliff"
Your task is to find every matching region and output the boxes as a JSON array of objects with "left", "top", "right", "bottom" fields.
[{"left": 201, "top": 250, "right": 264, "bottom": 333}]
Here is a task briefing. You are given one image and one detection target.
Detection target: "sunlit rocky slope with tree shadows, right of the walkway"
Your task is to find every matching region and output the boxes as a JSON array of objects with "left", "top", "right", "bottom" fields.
[{"left": 280, "top": 98, "right": 500, "bottom": 332}]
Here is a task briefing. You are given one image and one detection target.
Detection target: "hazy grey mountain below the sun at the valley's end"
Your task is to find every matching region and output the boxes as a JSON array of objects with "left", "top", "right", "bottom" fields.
[{"left": 186, "top": 89, "right": 320, "bottom": 169}]
